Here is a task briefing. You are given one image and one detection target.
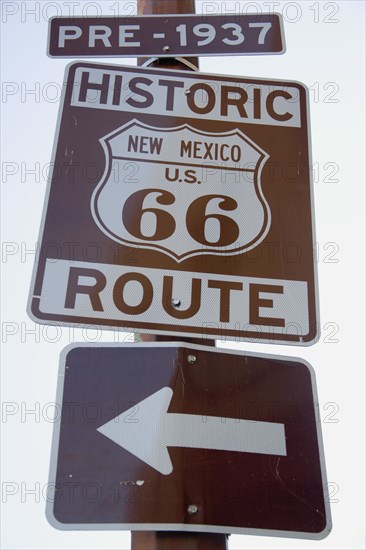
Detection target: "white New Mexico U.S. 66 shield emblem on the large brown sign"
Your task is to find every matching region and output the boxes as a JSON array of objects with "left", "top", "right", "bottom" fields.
[{"left": 92, "top": 120, "right": 270, "bottom": 262}]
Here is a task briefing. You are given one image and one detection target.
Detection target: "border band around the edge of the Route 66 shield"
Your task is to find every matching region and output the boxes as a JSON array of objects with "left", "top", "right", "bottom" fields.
[{"left": 91, "top": 119, "right": 271, "bottom": 263}]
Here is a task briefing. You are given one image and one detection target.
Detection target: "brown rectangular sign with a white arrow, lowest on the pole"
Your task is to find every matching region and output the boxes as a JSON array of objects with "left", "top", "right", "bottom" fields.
[{"left": 47, "top": 343, "right": 331, "bottom": 539}]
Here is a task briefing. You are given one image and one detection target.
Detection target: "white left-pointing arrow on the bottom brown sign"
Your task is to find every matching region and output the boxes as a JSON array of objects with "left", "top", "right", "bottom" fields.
[{"left": 98, "top": 387, "right": 287, "bottom": 475}]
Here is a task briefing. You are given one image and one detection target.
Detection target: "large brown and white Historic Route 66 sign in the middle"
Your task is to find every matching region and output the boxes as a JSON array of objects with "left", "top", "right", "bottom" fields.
[{"left": 30, "top": 62, "right": 318, "bottom": 345}]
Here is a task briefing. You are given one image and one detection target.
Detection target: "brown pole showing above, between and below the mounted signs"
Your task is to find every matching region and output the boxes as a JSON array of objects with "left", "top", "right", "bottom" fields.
[{"left": 131, "top": 0, "right": 227, "bottom": 550}]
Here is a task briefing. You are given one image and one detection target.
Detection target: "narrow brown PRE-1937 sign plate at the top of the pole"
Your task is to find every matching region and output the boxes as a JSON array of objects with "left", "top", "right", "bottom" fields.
[{"left": 48, "top": 13, "right": 285, "bottom": 57}]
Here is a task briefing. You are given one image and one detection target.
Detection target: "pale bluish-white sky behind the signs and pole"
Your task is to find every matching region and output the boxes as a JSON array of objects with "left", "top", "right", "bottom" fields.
[{"left": 1, "top": 0, "right": 365, "bottom": 550}]
